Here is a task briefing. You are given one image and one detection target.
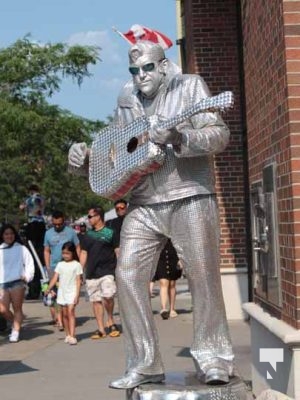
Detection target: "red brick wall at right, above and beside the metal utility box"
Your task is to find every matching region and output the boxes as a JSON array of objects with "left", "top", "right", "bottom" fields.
[{"left": 241, "top": 0, "right": 300, "bottom": 328}]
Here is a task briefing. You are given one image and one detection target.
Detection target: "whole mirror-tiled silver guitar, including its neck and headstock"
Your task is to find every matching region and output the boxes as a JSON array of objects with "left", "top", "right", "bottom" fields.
[{"left": 89, "top": 92, "right": 233, "bottom": 200}]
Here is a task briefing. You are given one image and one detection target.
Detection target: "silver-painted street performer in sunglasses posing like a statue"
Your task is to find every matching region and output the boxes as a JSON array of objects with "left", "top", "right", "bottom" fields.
[{"left": 69, "top": 41, "right": 234, "bottom": 389}]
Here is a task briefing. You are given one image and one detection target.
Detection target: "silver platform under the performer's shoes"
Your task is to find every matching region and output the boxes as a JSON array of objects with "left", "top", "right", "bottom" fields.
[{"left": 126, "top": 372, "right": 253, "bottom": 400}]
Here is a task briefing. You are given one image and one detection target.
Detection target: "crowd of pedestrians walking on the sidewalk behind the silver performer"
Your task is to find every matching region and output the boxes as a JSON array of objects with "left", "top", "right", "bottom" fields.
[{"left": 0, "top": 192, "right": 181, "bottom": 345}]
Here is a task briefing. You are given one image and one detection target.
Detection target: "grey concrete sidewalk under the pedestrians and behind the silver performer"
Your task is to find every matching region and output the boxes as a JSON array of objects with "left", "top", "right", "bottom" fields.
[{"left": 0, "top": 279, "right": 251, "bottom": 400}]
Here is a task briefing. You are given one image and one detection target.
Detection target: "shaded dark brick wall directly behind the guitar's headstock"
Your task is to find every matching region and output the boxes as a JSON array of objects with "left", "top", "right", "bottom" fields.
[{"left": 183, "top": 0, "right": 247, "bottom": 268}]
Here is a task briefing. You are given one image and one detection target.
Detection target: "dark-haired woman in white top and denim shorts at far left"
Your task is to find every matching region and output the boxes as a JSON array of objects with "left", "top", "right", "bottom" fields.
[{"left": 0, "top": 224, "right": 34, "bottom": 343}]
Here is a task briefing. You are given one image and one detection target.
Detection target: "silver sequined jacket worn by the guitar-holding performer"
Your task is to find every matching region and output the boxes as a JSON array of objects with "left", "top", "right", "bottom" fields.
[{"left": 114, "top": 74, "right": 230, "bottom": 205}]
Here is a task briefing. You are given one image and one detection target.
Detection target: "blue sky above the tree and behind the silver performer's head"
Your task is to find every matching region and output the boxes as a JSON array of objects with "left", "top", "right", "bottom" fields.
[{"left": 0, "top": 0, "right": 178, "bottom": 120}]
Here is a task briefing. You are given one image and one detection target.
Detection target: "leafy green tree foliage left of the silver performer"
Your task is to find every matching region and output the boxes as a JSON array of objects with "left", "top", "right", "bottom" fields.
[{"left": 0, "top": 37, "right": 109, "bottom": 220}]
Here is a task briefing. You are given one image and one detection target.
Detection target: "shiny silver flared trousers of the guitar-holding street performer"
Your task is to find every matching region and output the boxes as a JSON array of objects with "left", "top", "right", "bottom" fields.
[{"left": 116, "top": 195, "right": 234, "bottom": 375}]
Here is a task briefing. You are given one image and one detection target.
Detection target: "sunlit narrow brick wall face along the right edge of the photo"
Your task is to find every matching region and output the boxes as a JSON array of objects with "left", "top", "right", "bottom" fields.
[{"left": 281, "top": 1, "right": 300, "bottom": 329}]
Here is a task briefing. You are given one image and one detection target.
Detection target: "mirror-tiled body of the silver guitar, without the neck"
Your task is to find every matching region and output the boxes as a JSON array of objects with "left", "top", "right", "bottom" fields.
[{"left": 89, "top": 117, "right": 165, "bottom": 200}]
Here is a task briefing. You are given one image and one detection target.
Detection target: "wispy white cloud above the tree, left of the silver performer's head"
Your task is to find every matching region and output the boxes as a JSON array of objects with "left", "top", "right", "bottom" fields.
[{"left": 67, "top": 31, "right": 121, "bottom": 64}]
